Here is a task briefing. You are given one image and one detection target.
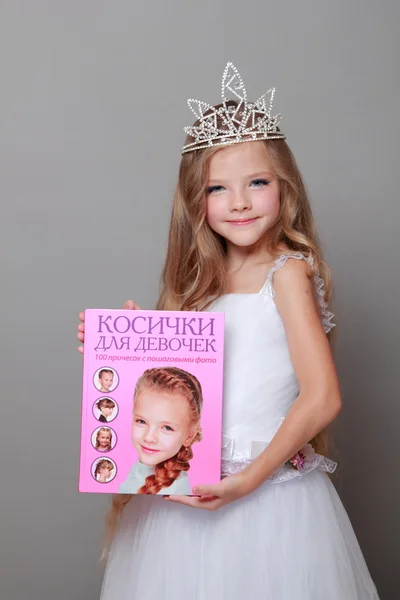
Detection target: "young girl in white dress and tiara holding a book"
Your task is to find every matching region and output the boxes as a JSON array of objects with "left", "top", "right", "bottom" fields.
[{"left": 78, "top": 64, "right": 378, "bottom": 600}]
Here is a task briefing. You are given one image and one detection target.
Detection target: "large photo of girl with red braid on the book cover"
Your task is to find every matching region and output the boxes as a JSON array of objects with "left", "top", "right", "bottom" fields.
[{"left": 119, "top": 367, "right": 203, "bottom": 495}]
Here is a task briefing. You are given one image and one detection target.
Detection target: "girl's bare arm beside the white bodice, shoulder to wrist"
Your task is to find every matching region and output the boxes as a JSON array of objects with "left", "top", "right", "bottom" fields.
[{"left": 243, "top": 260, "right": 341, "bottom": 493}]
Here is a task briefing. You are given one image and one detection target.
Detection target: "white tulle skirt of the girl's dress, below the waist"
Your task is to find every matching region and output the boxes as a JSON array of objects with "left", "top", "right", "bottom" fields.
[{"left": 101, "top": 471, "right": 378, "bottom": 600}]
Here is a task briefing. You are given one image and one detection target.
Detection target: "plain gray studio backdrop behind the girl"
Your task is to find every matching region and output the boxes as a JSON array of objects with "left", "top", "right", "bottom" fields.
[{"left": 0, "top": 0, "right": 400, "bottom": 600}]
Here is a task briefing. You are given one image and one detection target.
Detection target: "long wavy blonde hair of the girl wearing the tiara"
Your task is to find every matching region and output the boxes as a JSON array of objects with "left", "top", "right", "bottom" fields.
[{"left": 102, "top": 101, "right": 332, "bottom": 556}]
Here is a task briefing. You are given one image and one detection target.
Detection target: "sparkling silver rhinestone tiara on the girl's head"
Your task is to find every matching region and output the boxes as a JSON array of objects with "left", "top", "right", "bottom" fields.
[{"left": 182, "top": 62, "right": 286, "bottom": 154}]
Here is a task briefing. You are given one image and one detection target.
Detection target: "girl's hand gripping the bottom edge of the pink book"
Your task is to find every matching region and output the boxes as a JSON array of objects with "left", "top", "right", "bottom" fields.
[{"left": 163, "top": 473, "right": 250, "bottom": 510}]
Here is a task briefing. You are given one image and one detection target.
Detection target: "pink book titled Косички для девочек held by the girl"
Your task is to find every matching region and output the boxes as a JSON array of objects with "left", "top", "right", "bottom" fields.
[{"left": 79, "top": 309, "right": 224, "bottom": 495}]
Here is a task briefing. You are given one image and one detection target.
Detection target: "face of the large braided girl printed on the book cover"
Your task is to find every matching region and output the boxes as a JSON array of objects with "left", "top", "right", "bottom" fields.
[{"left": 132, "top": 389, "right": 198, "bottom": 466}]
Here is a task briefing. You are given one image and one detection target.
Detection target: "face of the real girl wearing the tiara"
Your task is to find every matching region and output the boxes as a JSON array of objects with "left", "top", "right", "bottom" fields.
[{"left": 207, "top": 142, "right": 280, "bottom": 248}]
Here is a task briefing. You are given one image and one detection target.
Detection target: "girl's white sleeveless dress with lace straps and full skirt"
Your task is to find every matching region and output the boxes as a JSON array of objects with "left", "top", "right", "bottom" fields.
[{"left": 101, "top": 253, "right": 378, "bottom": 600}]
